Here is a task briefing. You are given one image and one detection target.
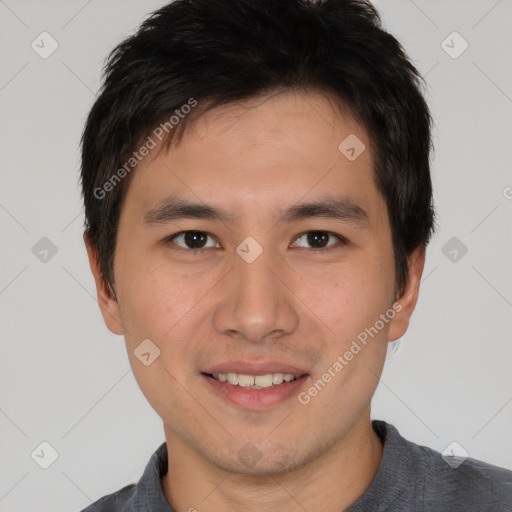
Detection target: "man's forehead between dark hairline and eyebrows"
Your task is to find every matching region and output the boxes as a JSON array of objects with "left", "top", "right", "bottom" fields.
[{"left": 121, "top": 92, "right": 382, "bottom": 226}]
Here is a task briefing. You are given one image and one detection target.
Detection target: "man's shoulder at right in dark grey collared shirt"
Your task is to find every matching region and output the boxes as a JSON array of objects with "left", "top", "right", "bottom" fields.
[{"left": 362, "top": 420, "right": 512, "bottom": 512}]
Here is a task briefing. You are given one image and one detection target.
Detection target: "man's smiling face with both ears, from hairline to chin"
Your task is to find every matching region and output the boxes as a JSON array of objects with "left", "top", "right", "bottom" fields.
[{"left": 89, "top": 93, "right": 423, "bottom": 475}]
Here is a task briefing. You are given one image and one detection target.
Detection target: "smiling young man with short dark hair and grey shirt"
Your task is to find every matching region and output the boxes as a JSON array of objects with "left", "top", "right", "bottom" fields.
[{"left": 82, "top": 0, "right": 512, "bottom": 512}]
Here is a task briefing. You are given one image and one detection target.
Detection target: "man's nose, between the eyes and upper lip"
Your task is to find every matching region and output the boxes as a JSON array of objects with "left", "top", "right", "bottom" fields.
[{"left": 213, "top": 244, "right": 299, "bottom": 343}]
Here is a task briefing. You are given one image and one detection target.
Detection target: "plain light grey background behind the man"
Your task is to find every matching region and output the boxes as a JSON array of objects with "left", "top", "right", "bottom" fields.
[{"left": 0, "top": 0, "right": 512, "bottom": 512}]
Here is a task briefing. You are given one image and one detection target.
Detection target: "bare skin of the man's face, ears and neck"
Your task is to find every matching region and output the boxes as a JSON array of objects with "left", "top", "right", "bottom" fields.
[{"left": 86, "top": 92, "right": 425, "bottom": 512}]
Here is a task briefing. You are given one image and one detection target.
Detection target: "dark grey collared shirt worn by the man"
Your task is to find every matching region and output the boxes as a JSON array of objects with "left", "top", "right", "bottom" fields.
[{"left": 81, "top": 420, "right": 512, "bottom": 512}]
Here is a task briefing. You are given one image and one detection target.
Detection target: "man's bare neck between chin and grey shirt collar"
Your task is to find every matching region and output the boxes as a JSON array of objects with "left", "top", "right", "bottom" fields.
[{"left": 162, "top": 410, "right": 383, "bottom": 512}]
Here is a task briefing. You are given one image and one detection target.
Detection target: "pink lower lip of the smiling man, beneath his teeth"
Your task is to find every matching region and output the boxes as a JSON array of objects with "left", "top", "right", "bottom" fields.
[{"left": 202, "top": 374, "right": 309, "bottom": 411}]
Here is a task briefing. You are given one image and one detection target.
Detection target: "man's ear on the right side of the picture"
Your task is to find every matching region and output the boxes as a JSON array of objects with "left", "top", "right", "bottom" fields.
[{"left": 388, "top": 246, "right": 425, "bottom": 341}]
